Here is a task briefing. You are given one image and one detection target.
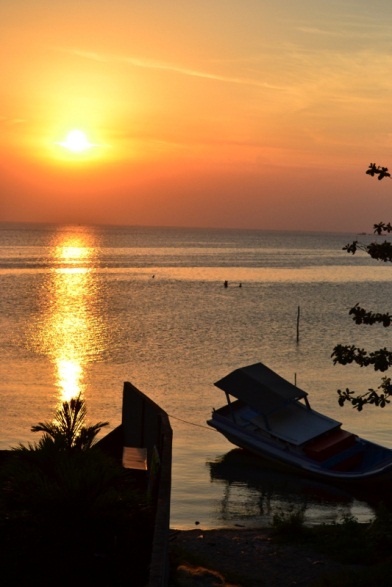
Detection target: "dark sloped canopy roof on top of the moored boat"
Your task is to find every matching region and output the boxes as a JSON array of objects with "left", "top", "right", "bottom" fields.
[{"left": 214, "top": 363, "right": 308, "bottom": 415}]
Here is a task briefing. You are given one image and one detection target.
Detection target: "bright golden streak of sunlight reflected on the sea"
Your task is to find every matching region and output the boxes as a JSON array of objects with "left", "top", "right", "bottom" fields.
[{"left": 29, "top": 229, "right": 104, "bottom": 401}]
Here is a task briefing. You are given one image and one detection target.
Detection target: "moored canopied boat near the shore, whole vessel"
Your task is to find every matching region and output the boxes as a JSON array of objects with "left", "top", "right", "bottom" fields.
[{"left": 207, "top": 363, "right": 392, "bottom": 484}]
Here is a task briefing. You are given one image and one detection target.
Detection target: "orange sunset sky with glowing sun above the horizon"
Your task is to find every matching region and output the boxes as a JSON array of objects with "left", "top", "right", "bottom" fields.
[{"left": 0, "top": 0, "right": 392, "bottom": 232}]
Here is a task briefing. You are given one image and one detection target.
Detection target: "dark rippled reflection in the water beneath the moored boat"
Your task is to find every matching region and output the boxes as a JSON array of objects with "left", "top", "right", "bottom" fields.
[{"left": 207, "top": 448, "right": 378, "bottom": 527}]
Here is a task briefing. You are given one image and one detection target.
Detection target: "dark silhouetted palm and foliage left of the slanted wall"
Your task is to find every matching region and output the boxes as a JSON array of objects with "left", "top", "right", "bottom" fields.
[{"left": 0, "top": 397, "right": 153, "bottom": 587}]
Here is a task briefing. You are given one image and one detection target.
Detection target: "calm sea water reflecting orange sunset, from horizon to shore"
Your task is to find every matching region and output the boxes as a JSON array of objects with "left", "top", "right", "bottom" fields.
[{"left": 0, "top": 224, "right": 392, "bottom": 528}]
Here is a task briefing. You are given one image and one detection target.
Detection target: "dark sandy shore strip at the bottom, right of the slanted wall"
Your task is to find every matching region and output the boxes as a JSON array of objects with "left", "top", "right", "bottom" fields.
[{"left": 170, "top": 528, "right": 358, "bottom": 587}]
